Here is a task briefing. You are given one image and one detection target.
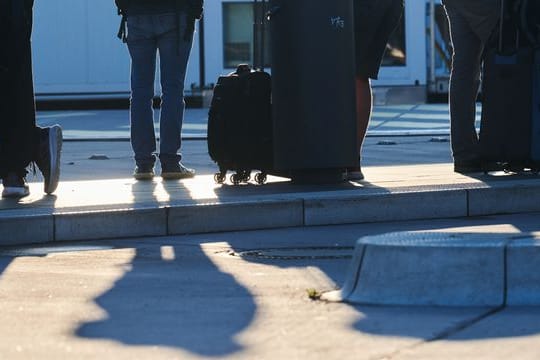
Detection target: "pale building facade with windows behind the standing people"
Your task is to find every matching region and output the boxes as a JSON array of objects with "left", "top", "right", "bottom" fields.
[{"left": 33, "top": 0, "right": 440, "bottom": 99}]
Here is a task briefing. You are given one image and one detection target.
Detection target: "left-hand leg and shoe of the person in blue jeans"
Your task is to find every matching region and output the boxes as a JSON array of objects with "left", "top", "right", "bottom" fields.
[{"left": 127, "top": 15, "right": 157, "bottom": 179}]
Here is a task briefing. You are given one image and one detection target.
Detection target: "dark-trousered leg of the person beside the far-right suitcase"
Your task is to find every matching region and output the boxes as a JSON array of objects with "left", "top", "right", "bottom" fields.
[{"left": 445, "top": 4, "right": 484, "bottom": 172}]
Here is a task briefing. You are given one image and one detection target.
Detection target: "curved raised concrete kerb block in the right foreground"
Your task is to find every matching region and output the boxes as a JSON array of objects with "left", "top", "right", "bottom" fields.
[{"left": 321, "top": 232, "right": 540, "bottom": 306}]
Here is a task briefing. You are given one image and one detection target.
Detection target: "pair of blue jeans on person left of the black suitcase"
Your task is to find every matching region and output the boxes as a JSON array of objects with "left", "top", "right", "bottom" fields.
[{"left": 127, "top": 14, "right": 193, "bottom": 165}]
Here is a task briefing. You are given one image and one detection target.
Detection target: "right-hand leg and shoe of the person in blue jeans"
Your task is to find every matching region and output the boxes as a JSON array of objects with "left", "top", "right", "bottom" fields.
[{"left": 158, "top": 14, "right": 195, "bottom": 179}]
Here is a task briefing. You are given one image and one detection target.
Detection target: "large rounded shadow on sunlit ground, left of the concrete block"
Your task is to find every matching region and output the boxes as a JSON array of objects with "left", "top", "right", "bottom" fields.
[{"left": 76, "top": 243, "right": 256, "bottom": 357}]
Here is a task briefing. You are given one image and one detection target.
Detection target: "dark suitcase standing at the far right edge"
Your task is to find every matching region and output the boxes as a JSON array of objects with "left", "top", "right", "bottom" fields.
[{"left": 479, "top": 0, "right": 540, "bottom": 172}]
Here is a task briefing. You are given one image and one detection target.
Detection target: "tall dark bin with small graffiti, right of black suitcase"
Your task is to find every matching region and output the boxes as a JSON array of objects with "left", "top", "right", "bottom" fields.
[{"left": 269, "top": 0, "right": 358, "bottom": 182}]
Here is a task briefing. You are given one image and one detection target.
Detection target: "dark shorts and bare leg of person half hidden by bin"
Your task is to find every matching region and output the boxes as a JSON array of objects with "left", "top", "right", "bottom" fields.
[{"left": 348, "top": 0, "right": 403, "bottom": 180}]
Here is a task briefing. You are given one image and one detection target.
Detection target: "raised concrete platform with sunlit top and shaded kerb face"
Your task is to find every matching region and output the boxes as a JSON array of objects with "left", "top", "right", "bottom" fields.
[{"left": 0, "top": 164, "right": 540, "bottom": 245}]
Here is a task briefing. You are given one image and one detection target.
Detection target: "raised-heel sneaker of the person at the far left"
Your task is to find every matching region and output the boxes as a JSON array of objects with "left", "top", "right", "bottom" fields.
[{"left": 35, "top": 125, "right": 62, "bottom": 194}]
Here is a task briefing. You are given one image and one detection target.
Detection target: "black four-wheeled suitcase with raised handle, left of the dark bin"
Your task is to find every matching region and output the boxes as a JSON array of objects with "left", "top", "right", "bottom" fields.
[{"left": 208, "top": 0, "right": 273, "bottom": 184}]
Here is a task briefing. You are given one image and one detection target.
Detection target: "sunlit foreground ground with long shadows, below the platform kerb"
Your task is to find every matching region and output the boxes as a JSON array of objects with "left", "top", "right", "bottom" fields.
[{"left": 0, "top": 214, "right": 540, "bottom": 360}]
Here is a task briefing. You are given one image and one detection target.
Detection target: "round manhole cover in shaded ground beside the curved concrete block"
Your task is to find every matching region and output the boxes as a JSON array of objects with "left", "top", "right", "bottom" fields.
[{"left": 230, "top": 246, "right": 354, "bottom": 260}]
